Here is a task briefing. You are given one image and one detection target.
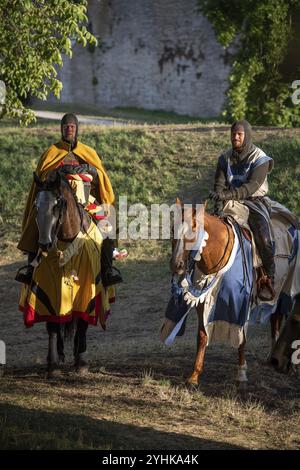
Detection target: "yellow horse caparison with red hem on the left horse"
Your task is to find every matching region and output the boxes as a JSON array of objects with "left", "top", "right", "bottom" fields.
[{"left": 19, "top": 222, "right": 115, "bottom": 330}]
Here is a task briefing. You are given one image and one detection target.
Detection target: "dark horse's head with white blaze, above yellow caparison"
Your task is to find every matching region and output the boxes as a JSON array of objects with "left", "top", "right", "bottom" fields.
[{"left": 34, "top": 171, "right": 66, "bottom": 251}]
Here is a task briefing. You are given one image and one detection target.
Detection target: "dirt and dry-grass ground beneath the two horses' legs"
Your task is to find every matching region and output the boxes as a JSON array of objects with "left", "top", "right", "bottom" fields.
[{"left": 0, "top": 253, "right": 300, "bottom": 449}]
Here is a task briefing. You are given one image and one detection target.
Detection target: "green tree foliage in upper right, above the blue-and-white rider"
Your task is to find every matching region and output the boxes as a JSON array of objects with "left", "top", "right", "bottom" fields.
[{"left": 199, "top": 0, "right": 300, "bottom": 126}]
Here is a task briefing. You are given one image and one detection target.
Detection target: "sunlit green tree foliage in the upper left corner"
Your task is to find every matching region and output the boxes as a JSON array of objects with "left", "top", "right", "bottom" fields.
[{"left": 0, "top": 0, "right": 97, "bottom": 125}]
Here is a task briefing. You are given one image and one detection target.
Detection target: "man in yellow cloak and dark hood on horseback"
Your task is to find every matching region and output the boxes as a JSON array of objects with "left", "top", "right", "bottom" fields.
[{"left": 17, "top": 114, "right": 122, "bottom": 286}]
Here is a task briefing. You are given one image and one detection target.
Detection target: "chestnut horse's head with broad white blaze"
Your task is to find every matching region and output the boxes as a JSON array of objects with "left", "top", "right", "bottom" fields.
[{"left": 170, "top": 198, "right": 201, "bottom": 275}]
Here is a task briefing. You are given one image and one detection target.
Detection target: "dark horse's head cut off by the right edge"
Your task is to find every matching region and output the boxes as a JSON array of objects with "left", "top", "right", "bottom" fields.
[{"left": 271, "top": 295, "right": 300, "bottom": 373}]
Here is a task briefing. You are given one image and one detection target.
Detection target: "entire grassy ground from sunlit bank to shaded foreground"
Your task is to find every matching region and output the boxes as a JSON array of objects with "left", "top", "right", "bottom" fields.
[{"left": 0, "top": 119, "right": 300, "bottom": 449}]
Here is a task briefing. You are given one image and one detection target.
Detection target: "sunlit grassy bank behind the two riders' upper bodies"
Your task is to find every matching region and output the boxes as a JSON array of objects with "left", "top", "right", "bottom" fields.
[{"left": 0, "top": 119, "right": 300, "bottom": 255}]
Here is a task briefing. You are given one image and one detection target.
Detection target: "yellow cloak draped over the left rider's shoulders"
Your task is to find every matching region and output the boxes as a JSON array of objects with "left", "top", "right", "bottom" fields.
[{"left": 18, "top": 140, "right": 115, "bottom": 253}]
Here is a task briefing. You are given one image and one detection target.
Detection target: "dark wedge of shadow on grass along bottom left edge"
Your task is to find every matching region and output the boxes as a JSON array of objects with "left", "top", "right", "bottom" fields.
[{"left": 0, "top": 404, "right": 244, "bottom": 450}]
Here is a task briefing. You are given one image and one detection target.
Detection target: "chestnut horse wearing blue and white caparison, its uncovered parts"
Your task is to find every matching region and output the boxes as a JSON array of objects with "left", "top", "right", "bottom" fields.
[{"left": 161, "top": 199, "right": 288, "bottom": 386}]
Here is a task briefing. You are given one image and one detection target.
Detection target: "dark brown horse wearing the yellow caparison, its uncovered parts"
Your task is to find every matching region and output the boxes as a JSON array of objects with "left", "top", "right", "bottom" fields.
[{"left": 34, "top": 167, "right": 91, "bottom": 378}]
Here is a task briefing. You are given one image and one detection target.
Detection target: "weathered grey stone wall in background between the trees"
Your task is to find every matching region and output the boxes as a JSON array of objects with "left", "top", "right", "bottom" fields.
[{"left": 51, "top": 0, "right": 229, "bottom": 117}]
